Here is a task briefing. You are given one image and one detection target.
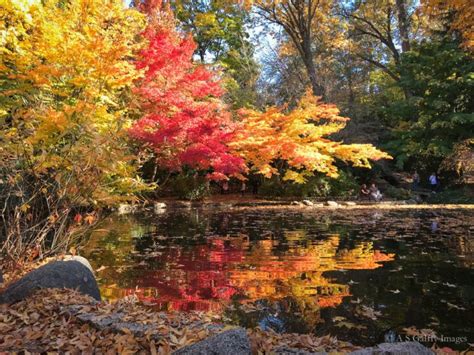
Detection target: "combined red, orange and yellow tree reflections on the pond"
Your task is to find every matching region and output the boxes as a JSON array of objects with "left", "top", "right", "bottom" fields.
[{"left": 83, "top": 218, "right": 394, "bottom": 311}]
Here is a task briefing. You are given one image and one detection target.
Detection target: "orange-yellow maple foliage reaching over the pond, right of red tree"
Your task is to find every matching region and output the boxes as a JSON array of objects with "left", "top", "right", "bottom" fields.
[{"left": 231, "top": 91, "right": 390, "bottom": 183}]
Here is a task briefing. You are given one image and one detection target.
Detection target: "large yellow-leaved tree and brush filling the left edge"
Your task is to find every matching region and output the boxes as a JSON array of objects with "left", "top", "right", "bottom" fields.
[{"left": 0, "top": 0, "right": 148, "bottom": 257}]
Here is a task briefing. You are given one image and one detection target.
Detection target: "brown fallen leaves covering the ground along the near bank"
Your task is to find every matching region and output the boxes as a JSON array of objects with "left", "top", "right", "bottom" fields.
[{"left": 0, "top": 289, "right": 358, "bottom": 354}]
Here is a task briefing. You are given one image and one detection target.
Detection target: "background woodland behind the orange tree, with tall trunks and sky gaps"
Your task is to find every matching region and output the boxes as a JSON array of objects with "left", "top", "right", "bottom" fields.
[{"left": 166, "top": 0, "right": 474, "bottom": 197}]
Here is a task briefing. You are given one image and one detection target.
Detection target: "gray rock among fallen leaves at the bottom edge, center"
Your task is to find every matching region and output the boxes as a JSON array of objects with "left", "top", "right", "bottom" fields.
[{"left": 173, "top": 328, "right": 251, "bottom": 355}]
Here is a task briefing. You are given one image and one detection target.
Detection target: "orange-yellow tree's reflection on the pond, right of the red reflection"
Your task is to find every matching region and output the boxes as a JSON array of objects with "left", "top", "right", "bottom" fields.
[{"left": 229, "top": 231, "right": 394, "bottom": 307}]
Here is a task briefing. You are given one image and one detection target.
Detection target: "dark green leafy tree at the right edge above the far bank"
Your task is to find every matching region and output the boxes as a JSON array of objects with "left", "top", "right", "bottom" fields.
[{"left": 384, "top": 38, "right": 474, "bottom": 170}]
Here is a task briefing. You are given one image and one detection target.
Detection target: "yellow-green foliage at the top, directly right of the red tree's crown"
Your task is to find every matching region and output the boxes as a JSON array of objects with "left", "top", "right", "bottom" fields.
[{"left": 175, "top": 0, "right": 259, "bottom": 109}]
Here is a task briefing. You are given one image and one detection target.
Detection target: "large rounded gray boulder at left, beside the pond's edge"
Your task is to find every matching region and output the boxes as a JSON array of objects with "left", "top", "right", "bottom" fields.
[{"left": 0, "top": 257, "right": 100, "bottom": 304}]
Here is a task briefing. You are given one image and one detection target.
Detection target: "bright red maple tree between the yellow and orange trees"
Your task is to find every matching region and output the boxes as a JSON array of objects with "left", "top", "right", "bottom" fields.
[{"left": 130, "top": 4, "right": 245, "bottom": 184}]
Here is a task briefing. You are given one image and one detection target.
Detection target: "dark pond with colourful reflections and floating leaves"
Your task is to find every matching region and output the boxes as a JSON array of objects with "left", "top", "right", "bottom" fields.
[{"left": 82, "top": 207, "right": 474, "bottom": 349}]
